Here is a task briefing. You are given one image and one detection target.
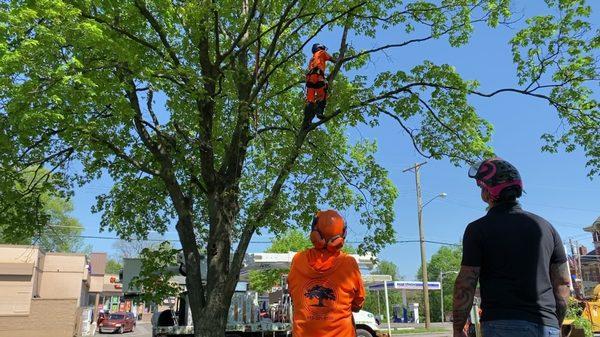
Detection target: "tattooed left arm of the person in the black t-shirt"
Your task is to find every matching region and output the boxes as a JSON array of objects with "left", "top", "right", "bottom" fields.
[{"left": 452, "top": 266, "right": 480, "bottom": 331}]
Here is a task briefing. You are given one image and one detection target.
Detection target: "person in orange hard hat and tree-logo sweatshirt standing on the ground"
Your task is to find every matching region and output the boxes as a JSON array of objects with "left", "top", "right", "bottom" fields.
[{"left": 288, "top": 210, "right": 365, "bottom": 337}]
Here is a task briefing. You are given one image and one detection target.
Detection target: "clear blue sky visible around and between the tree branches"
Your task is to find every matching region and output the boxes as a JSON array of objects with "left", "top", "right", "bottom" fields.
[{"left": 73, "top": 1, "right": 600, "bottom": 279}]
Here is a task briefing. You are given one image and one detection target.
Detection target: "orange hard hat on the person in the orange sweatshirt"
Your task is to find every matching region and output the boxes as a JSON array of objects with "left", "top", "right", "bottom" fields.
[{"left": 310, "top": 209, "right": 347, "bottom": 252}]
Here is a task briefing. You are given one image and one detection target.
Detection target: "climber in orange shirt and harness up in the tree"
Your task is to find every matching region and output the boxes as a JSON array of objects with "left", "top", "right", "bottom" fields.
[{"left": 306, "top": 43, "right": 333, "bottom": 119}]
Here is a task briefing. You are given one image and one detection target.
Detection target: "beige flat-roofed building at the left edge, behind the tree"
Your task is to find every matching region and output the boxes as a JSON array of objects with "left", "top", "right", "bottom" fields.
[{"left": 0, "top": 245, "right": 122, "bottom": 337}]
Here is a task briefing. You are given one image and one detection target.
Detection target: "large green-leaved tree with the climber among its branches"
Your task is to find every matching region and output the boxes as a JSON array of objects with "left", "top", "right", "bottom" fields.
[{"left": 0, "top": 0, "right": 600, "bottom": 336}]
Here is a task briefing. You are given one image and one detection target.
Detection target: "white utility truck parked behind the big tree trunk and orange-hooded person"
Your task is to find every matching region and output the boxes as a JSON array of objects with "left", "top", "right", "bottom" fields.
[{"left": 152, "top": 253, "right": 387, "bottom": 337}]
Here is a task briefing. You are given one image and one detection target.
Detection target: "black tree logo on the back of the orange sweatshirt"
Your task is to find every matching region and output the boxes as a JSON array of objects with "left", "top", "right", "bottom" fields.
[{"left": 303, "top": 280, "right": 338, "bottom": 320}]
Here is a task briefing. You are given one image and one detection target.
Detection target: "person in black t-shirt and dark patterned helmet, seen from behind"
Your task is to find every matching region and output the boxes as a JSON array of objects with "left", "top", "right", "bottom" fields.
[{"left": 453, "top": 158, "right": 569, "bottom": 337}]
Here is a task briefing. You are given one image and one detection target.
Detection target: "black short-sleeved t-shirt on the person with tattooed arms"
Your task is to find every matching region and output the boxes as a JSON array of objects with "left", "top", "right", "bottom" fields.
[{"left": 462, "top": 203, "right": 567, "bottom": 327}]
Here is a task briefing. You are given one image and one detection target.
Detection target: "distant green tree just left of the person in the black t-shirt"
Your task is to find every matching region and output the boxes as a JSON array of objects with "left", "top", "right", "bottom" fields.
[{"left": 417, "top": 246, "right": 462, "bottom": 321}]
